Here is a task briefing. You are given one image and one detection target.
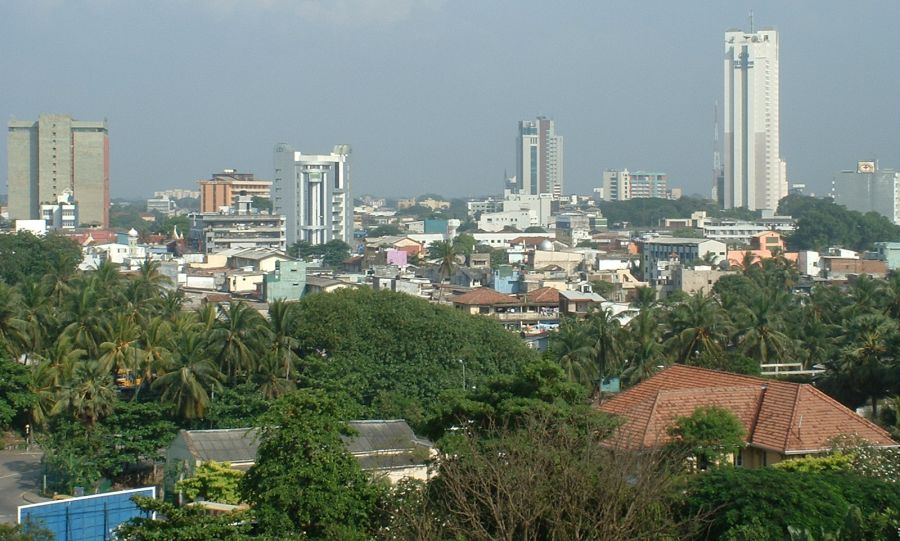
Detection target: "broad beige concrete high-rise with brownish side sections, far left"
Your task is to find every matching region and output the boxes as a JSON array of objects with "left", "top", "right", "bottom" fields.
[{"left": 7, "top": 115, "right": 109, "bottom": 227}]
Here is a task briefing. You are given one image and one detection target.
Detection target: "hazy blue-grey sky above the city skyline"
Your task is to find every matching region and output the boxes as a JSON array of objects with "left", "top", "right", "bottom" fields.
[{"left": 0, "top": 0, "right": 900, "bottom": 197}]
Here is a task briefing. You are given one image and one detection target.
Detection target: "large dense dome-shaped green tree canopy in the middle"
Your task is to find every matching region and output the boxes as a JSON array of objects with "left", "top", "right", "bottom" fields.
[{"left": 294, "top": 289, "right": 535, "bottom": 422}]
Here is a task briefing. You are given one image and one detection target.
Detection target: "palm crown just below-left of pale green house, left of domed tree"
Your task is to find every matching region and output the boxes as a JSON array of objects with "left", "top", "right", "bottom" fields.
[{"left": 209, "top": 302, "right": 265, "bottom": 383}]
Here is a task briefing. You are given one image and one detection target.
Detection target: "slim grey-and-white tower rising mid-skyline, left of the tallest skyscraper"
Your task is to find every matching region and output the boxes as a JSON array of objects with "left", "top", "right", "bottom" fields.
[{"left": 516, "top": 116, "right": 564, "bottom": 199}]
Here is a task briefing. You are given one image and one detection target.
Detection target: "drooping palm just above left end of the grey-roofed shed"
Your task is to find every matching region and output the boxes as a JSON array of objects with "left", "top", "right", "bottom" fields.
[{"left": 152, "top": 333, "right": 222, "bottom": 419}]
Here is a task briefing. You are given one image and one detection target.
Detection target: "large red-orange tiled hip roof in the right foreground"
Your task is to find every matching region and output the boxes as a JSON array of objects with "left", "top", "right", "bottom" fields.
[{"left": 599, "top": 365, "right": 897, "bottom": 454}]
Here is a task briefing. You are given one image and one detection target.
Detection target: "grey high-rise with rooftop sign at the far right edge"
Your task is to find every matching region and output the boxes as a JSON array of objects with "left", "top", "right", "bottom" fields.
[{"left": 831, "top": 161, "right": 900, "bottom": 224}]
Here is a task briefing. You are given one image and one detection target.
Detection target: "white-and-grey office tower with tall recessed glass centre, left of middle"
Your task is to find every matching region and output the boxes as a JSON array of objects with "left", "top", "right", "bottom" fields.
[{"left": 272, "top": 143, "right": 353, "bottom": 246}]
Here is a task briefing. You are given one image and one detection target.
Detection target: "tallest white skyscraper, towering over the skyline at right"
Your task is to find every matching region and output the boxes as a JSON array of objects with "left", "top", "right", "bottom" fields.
[{"left": 719, "top": 24, "right": 788, "bottom": 210}]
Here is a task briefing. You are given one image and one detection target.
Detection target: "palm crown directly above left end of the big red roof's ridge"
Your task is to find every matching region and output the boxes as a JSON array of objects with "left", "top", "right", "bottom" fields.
[{"left": 667, "top": 291, "right": 731, "bottom": 364}]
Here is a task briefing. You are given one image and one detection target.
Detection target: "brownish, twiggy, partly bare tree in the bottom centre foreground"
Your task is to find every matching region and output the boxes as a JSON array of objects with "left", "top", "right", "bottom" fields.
[{"left": 382, "top": 413, "right": 696, "bottom": 541}]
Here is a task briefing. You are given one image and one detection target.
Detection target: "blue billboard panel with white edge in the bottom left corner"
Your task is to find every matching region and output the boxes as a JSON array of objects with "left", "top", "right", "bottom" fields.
[{"left": 18, "top": 487, "right": 156, "bottom": 541}]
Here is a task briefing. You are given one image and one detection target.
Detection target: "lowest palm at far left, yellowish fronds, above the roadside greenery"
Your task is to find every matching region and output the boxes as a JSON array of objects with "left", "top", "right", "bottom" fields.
[{"left": 50, "top": 361, "right": 118, "bottom": 430}]
